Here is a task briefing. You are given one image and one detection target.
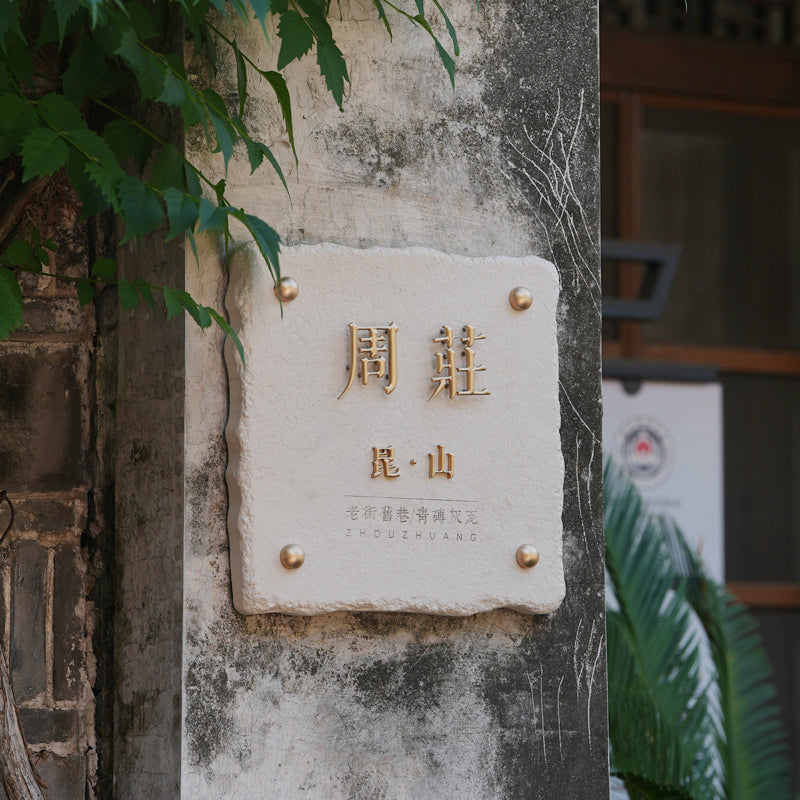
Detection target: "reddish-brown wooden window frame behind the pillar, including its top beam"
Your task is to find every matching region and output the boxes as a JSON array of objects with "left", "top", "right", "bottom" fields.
[{"left": 600, "top": 29, "right": 800, "bottom": 610}]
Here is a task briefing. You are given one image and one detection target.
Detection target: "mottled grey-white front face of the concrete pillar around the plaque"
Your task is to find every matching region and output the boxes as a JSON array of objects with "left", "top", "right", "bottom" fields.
[{"left": 180, "top": 0, "right": 608, "bottom": 800}]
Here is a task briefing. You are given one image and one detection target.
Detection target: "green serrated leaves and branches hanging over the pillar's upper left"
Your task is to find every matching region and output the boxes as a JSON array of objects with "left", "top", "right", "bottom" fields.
[{"left": 0, "top": 0, "right": 458, "bottom": 347}]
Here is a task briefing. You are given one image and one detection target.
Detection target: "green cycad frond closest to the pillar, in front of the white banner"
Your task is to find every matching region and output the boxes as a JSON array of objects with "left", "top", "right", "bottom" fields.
[{"left": 605, "top": 468, "right": 721, "bottom": 800}]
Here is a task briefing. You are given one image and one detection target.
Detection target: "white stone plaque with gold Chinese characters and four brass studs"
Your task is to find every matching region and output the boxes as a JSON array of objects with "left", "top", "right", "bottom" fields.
[{"left": 227, "top": 245, "right": 564, "bottom": 615}]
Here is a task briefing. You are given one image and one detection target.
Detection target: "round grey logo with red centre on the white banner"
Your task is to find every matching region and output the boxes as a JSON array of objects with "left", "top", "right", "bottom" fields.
[{"left": 614, "top": 417, "right": 675, "bottom": 488}]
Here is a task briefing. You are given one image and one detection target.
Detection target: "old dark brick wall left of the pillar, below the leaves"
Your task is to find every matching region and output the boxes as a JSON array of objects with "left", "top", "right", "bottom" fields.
[{"left": 0, "top": 185, "right": 113, "bottom": 800}]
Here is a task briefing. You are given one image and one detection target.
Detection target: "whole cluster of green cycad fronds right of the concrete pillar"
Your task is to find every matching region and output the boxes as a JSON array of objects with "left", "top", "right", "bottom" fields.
[{"left": 605, "top": 465, "right": 791, "bottom": 800}]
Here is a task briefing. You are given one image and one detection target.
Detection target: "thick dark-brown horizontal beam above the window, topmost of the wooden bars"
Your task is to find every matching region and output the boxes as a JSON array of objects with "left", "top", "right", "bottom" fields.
[{"left": 600, "top": 29, "right": 800, "bottom": 106}]
